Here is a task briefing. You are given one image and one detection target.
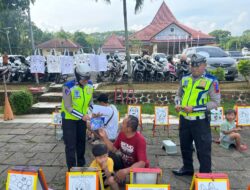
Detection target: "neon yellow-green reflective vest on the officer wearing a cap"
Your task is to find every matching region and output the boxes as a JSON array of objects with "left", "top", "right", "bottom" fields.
[{"left": 180, "top": 75, "right": 213, "bottom": 116}]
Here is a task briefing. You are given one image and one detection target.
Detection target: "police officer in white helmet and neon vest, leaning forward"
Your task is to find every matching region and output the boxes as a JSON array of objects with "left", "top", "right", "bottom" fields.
[{"left": 61, "top": 64, "right": 93, "bottom": 170}]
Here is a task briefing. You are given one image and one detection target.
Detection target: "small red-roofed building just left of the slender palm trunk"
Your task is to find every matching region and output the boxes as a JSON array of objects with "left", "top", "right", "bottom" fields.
[{"left": 102, "top": 34, "right": 125, "bottom": 54}]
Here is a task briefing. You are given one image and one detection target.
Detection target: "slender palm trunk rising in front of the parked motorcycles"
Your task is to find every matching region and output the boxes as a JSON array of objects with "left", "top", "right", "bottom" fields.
[{"left": 123, "top": 0, "right": 132, "bottom": 85}]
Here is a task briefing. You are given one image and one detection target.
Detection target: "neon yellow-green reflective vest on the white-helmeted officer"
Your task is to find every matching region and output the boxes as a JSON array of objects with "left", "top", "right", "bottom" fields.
[{"left": 61, "top": 84, "right": 94, "bottom": 120}]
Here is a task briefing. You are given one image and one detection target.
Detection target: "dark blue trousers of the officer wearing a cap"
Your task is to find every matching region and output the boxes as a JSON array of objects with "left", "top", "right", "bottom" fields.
[{"left": 179, "top": 116, "right": 212, "bottom": 173}]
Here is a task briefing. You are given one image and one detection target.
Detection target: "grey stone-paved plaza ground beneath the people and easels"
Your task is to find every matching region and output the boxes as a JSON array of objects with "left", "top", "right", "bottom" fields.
[{"left": 0, "top": 115, "right": 250, "bottom": 190}]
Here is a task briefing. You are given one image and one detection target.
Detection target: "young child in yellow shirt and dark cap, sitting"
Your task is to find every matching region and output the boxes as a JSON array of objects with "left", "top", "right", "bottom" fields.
[{"left": 90, "top": 144, "right": 119, "bottom": 190}]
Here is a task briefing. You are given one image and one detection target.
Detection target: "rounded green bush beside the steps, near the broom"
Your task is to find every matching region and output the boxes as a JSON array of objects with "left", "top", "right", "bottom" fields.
[{"left": 10, "top": 91, "right": 33, "bottom": 115}]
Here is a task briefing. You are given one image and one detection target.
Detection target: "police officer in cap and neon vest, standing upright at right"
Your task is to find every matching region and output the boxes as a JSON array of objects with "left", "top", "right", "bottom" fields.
[{"left": 173, "top": 54, "right": 221, "bottom": 176}]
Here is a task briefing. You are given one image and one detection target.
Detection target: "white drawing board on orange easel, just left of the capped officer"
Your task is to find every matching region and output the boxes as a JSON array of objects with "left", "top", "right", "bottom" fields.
[{"left": 155, "top": 106, "right": 169, "bottom": 125}]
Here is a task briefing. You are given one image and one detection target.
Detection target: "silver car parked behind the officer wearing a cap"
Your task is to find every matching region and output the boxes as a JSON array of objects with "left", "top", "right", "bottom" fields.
[{"left": 183, "top": 46, "right": 238, "bottom": 81}]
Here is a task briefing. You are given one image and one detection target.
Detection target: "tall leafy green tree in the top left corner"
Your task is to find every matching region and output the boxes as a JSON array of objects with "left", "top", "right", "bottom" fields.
[{"left": 0, "top": 0, "right": 35, "bottom": 54}]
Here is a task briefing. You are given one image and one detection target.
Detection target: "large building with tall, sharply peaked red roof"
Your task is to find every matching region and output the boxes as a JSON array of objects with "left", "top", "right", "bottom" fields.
[{"left": 129, "top": 1, "right": 215, "bottom": 54}]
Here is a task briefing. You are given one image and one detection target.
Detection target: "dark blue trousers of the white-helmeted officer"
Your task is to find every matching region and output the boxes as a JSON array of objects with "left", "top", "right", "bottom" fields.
[{"left": 62, "top": 119, "right": 86, "bottom": 169}]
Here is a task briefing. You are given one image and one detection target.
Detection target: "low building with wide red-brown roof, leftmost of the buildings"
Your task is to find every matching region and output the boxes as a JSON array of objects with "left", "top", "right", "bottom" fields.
[{"left": 36, "top": 39, "right": 82, "bottom": 56}]
